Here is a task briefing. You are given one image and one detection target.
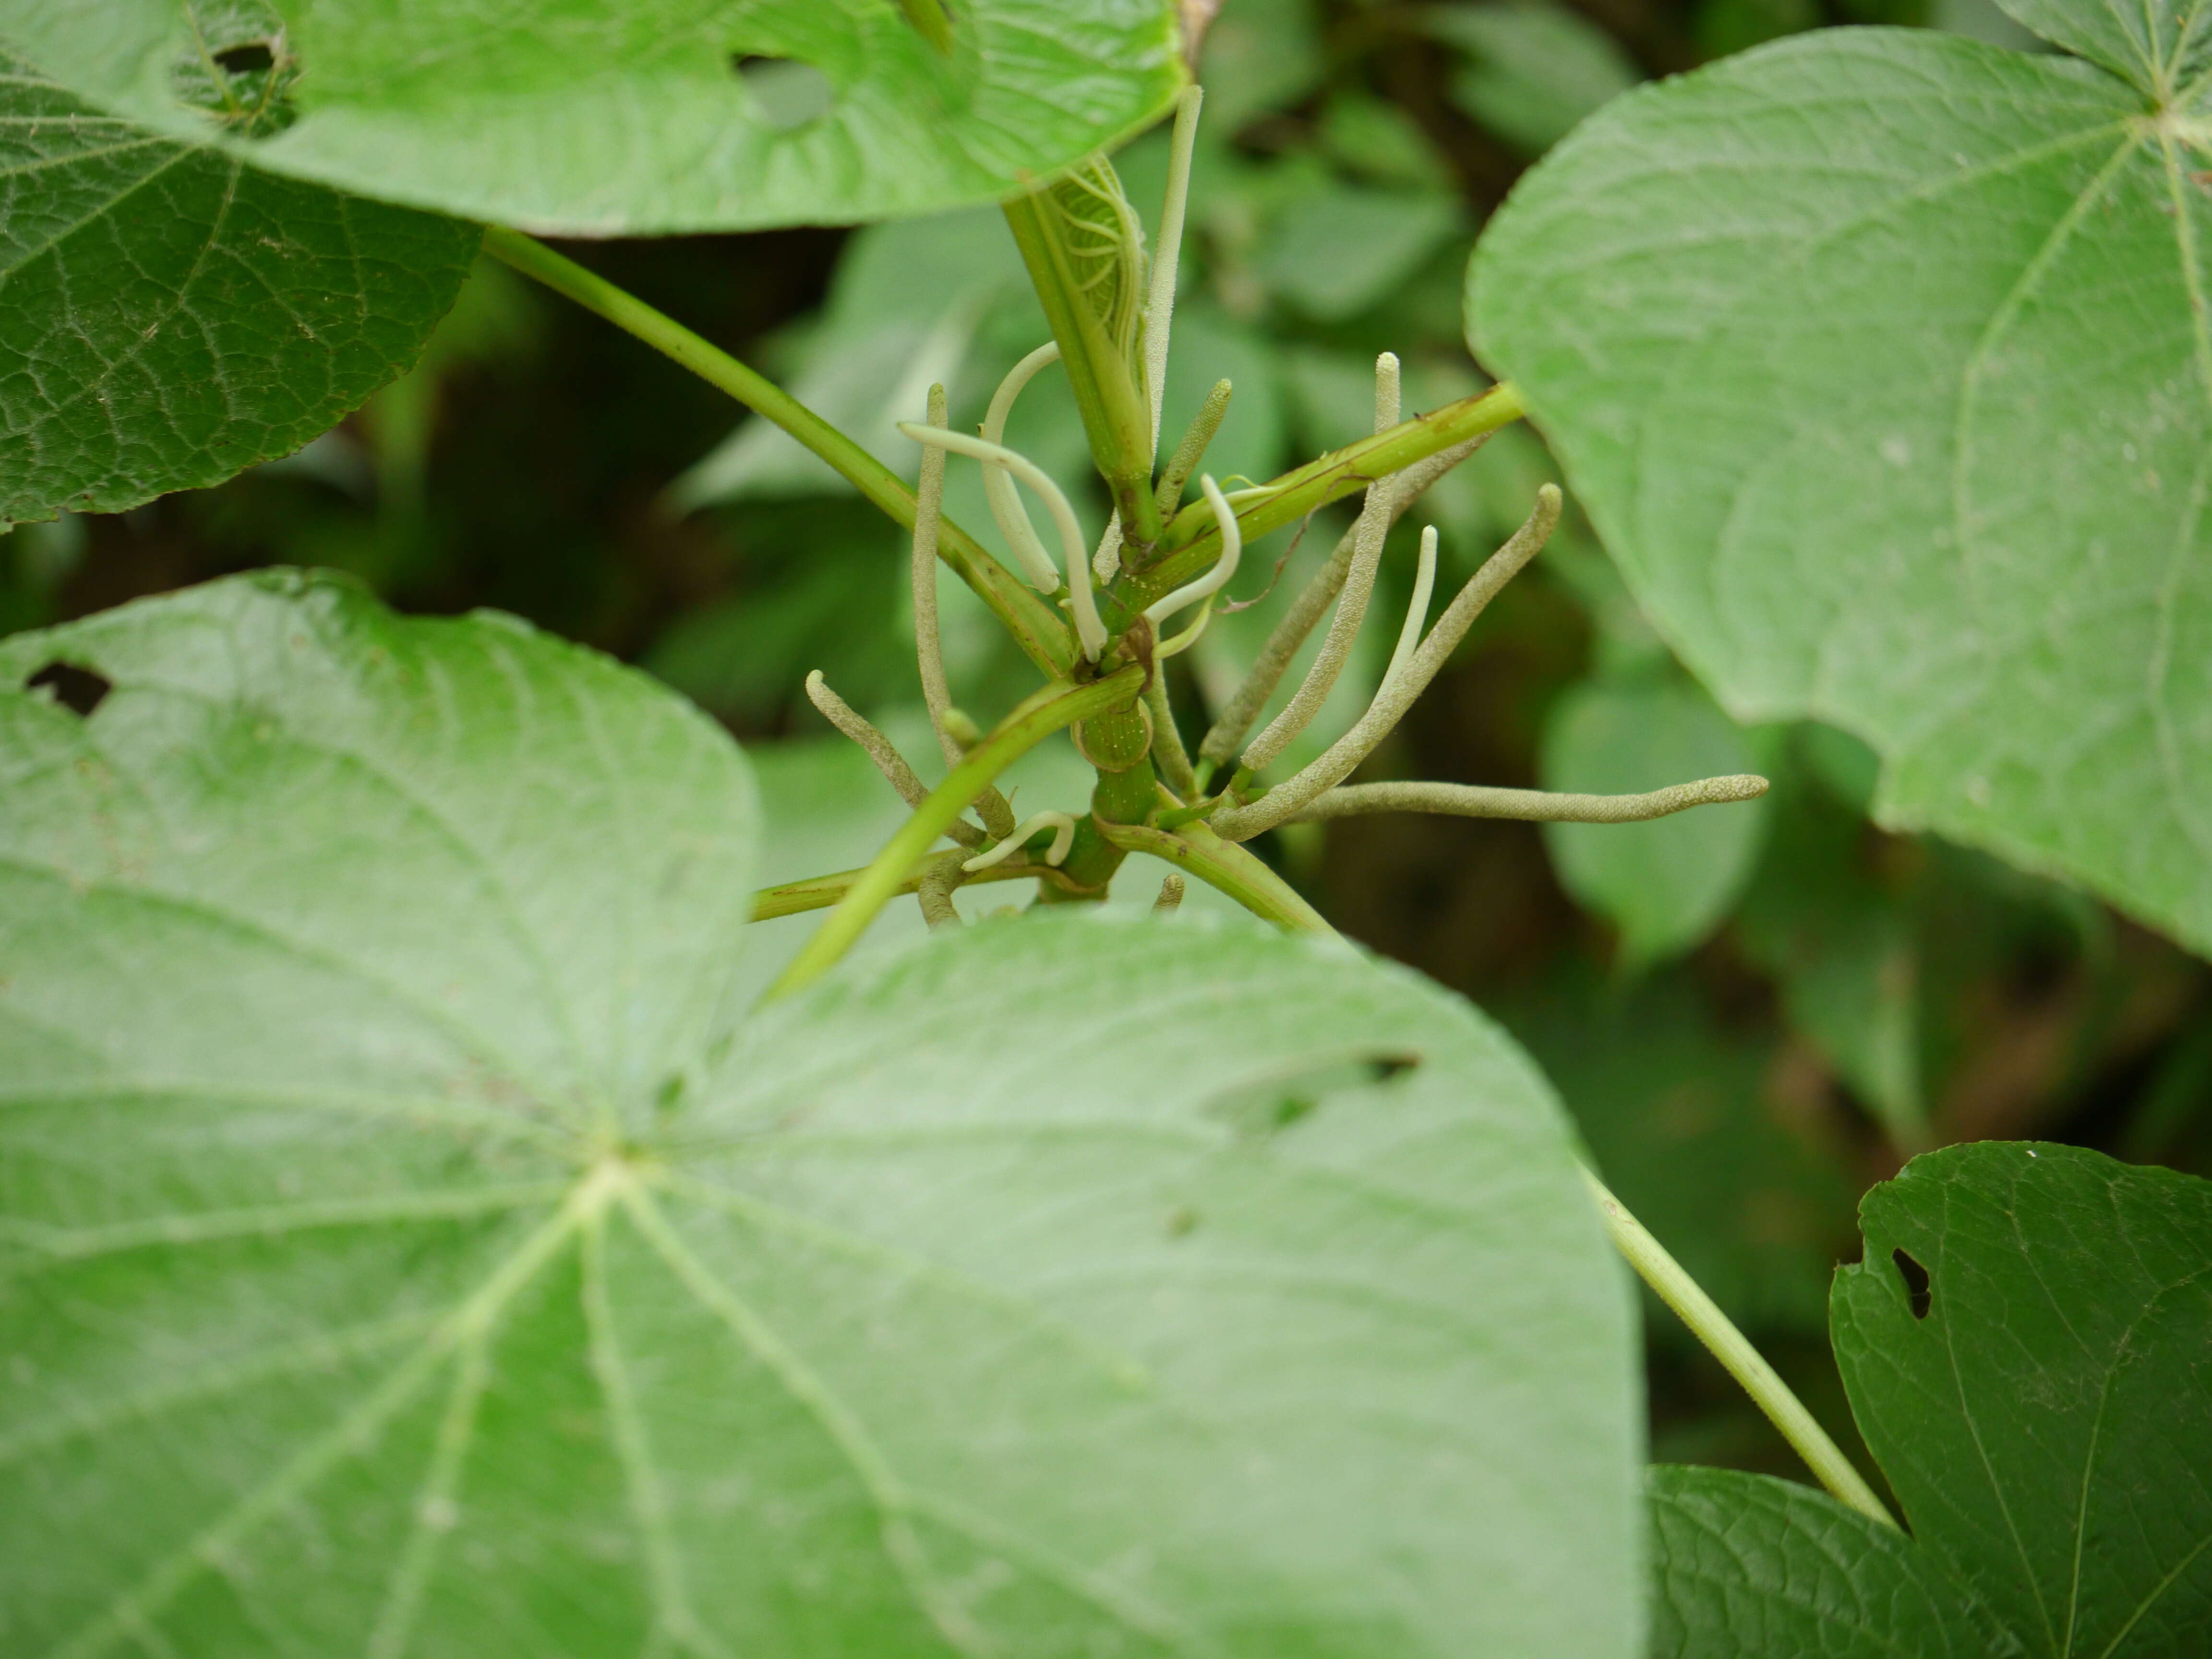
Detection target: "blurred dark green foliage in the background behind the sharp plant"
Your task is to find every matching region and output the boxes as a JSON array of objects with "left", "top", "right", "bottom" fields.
[{"left": 13, "top": 0, "right": 2212, "bottom": 1504}]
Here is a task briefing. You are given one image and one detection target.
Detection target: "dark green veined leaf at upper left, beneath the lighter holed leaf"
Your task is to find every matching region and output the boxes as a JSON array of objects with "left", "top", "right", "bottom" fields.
[{"left": 0, "top": 51, "right": 478, "bottom": 522}]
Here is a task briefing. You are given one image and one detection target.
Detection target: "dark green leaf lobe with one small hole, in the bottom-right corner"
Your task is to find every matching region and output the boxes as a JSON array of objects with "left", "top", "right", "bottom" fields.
[{"left": 1829, "top": 1142, "right": 2212, "bottom": 1659}]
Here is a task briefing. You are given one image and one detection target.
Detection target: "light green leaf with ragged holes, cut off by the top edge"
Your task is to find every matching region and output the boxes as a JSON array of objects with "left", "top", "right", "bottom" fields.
[{"left": 9, "top": 0, "right": 1183, "bottom": 237}]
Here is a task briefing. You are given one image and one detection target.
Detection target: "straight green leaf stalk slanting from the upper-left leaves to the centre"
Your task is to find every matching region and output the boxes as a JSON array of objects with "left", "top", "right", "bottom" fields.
[{"left": 484, "top": 226, "right": 1075, "bottom": 679}]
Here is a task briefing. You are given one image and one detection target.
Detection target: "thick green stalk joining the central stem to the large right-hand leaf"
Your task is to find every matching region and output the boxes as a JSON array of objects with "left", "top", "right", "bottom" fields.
[{"left": 1121, "top": 381, "right": 1527, "bottom": 611}]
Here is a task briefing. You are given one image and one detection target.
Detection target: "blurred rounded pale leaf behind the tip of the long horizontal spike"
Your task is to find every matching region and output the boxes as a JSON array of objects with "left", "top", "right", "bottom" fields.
[{"left": 1542, "top": 679, "right": 1765, "bottom": 962}]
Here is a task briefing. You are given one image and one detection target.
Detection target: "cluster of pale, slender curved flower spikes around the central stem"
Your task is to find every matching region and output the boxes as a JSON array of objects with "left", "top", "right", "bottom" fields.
[{"left": 807, "top": 86, "right": 1767, "bottom": 927}]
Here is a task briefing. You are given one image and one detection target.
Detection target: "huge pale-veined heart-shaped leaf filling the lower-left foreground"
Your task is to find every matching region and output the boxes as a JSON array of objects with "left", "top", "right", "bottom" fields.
[{"left": 0, "top": 575, "right": 1641, "bottom": 1659}]
